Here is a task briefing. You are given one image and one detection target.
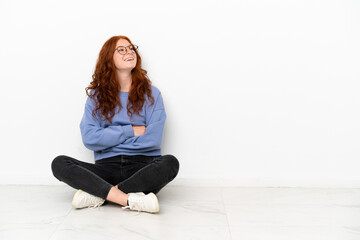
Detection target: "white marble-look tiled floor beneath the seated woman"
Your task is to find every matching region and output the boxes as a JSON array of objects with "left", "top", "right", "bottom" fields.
[{"left": 0, "top": 185, "right": 360, "bottom": 240}]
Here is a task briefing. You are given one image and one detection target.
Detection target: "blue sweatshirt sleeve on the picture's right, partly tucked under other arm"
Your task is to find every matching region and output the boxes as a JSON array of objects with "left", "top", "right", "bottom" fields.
[{"left": 119, "top": 92, "right": 166, "bottom": 152}]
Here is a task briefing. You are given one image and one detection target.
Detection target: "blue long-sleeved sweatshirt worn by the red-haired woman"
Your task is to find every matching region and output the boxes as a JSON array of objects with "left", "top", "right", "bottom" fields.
[{"left": 80, "top": 86, "right": 166, "bottom": 161}]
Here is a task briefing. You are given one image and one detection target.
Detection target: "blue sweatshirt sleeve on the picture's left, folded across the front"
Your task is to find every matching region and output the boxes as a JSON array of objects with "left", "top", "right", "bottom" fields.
[{"left": 80, "top": 97, "right": 134, "bottom": 151}]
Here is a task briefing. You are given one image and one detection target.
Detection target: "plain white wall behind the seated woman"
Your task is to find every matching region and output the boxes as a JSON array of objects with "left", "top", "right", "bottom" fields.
[{"left": 0, "top": 0, "right": 360, "bottom": 187}]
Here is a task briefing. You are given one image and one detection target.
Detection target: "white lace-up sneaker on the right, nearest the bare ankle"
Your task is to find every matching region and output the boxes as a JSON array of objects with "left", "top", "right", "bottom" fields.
[{"left": 123, "top": 193, "right": 160, "bottom": 213}]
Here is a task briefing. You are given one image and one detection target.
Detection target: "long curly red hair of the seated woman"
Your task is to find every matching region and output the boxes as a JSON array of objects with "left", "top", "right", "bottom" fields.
[{"left": 85, "top": 36, "right": 154, "bottom": 123}]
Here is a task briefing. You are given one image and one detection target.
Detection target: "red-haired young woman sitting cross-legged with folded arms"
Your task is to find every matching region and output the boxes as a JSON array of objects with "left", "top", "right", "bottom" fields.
[{"left": 51, "top": 36, "right": 179, "bottom": 213}]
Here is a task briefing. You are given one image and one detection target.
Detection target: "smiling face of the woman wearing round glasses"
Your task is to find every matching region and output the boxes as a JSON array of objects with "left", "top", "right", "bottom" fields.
[{"left": 113, "top": 39, "right": 137, "bottom": 71}]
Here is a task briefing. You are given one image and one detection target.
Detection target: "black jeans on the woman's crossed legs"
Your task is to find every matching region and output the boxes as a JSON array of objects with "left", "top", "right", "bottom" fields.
[{"left": 51, "top": 155, "right": 179, "bottom": 199}]
